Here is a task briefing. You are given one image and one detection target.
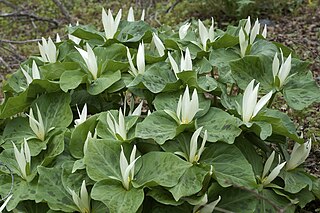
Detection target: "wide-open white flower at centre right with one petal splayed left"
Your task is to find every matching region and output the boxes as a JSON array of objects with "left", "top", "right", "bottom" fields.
[{"left": 165, "top": 85, "right": 200, "bottom": 125}]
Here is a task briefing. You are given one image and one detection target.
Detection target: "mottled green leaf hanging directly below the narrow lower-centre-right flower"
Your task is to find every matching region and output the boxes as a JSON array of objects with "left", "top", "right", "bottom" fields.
[{"left": 169, "top": 165, "right": 208, "bottom": 201}]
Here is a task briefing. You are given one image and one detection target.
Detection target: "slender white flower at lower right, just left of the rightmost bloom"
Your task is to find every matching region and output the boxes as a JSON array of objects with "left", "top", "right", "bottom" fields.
[{"left": 261, "top": 151, "right": 286, "bottom": 186}]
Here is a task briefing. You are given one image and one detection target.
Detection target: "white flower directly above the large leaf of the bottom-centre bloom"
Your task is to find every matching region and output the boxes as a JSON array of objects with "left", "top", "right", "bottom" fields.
[{"left": 107, "top": 108, "right": 127, "bottom": 140}]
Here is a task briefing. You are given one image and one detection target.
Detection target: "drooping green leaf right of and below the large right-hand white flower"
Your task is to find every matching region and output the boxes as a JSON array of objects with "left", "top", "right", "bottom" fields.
[{"left": 254, "top": 109, "right": 303, "bottom": 143}]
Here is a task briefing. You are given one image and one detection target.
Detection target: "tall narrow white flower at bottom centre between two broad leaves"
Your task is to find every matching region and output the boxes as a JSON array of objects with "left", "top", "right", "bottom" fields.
[{"left": 120, "top": 145, "right": 141, "bottom": 190}]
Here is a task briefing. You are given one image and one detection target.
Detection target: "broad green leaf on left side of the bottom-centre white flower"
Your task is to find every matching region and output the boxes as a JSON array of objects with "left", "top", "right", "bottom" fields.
[{"left": 84, "top": 140, "right": 121, "bottom": 181}]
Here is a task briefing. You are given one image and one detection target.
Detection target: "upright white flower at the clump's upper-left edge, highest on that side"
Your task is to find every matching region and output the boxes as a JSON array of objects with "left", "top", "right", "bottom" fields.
[{"left": 38, "top": 37, "right": 58, "bottom": 63}]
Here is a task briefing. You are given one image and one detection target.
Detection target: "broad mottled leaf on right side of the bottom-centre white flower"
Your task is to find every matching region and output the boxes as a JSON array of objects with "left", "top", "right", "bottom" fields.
[{"left": 133, "top": 152, "right": 192, "bottom": 188}]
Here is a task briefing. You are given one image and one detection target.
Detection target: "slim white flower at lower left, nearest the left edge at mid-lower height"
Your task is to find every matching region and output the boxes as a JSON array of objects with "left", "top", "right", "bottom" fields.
[{"left": 12, "top": 138, "right": 31, "bottom": 180}]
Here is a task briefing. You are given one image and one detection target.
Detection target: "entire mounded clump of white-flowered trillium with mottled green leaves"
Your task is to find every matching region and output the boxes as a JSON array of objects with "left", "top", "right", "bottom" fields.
[{"left": 0, "top": 7, "right": 320, "bottom": 213}]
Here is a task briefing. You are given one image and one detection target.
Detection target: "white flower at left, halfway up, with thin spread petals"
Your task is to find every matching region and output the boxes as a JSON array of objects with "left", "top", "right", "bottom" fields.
[{"left": 27, "top": 105, "right": 46, "bottom": 141}]
